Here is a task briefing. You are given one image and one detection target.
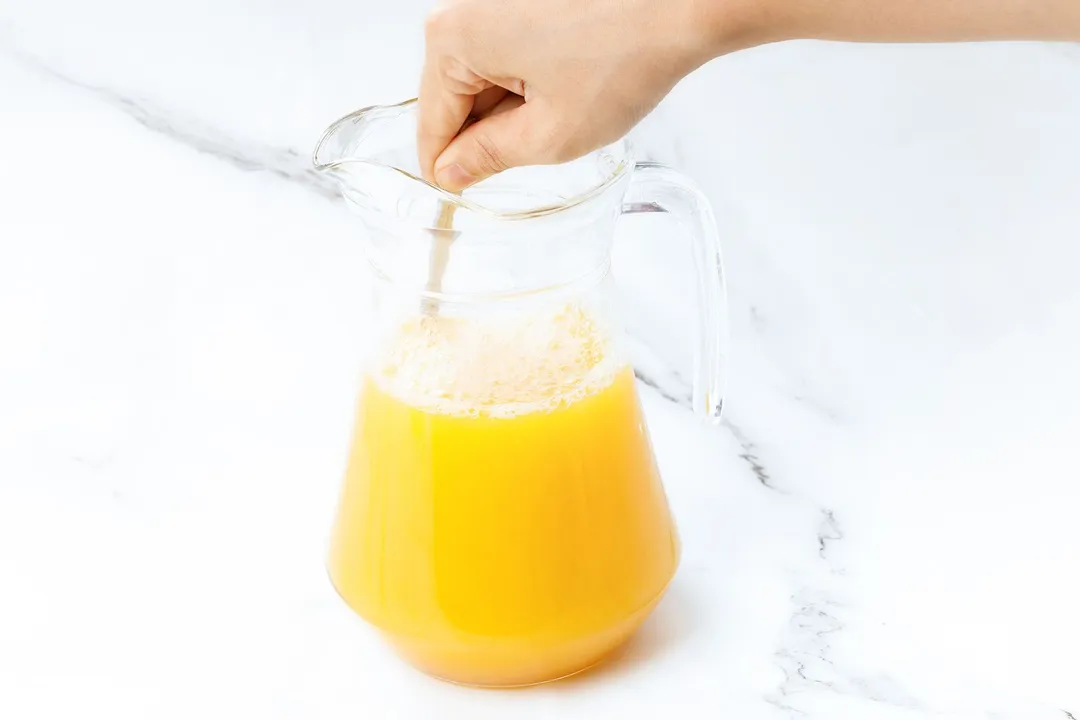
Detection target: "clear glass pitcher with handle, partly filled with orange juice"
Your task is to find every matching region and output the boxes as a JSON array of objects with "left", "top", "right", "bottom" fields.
[{"left": 314, "top": 100, "right": 726, "bottom": 687}]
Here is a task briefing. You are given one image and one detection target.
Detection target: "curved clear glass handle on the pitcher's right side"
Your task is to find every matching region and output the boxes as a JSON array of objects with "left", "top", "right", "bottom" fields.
[{"left": 621, "top": 162, "right": 728, "bottom": 423}]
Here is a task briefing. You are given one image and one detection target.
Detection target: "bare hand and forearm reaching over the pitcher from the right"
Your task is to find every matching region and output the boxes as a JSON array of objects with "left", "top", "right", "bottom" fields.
[{"left": 417, "top": 0, "right": 1080, "bottom": 192}]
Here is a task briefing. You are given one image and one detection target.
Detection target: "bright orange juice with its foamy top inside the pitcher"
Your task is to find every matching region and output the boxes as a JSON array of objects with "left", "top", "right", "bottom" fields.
[{"left": 329, "top": 307, "right": 678, "bottom": 685}]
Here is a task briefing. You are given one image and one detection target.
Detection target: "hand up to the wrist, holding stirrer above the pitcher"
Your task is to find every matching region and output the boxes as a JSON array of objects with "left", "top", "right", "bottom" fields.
[{"left": 417, "top": 0, "right": 750, "bottom": 191}]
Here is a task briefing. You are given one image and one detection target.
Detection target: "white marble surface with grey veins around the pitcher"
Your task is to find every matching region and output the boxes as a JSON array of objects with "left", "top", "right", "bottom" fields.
[{"left": 0, "top": 0, "right": 1080, "bottom": 720}]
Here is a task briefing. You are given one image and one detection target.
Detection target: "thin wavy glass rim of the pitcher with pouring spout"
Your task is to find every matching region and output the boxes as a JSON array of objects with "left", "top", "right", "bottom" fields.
[{"left": 311, "top": 97, "right": 634, "bottom": 220}]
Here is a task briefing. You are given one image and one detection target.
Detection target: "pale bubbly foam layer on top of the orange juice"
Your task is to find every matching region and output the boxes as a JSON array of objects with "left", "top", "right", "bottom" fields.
[{"left": 372, "top": 305, "right": 622, "bottom": 417}]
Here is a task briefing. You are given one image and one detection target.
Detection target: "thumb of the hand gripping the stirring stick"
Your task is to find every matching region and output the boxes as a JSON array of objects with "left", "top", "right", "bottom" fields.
[{"left": 435, "top": 103, "right": 548, "bottom": 192}]
